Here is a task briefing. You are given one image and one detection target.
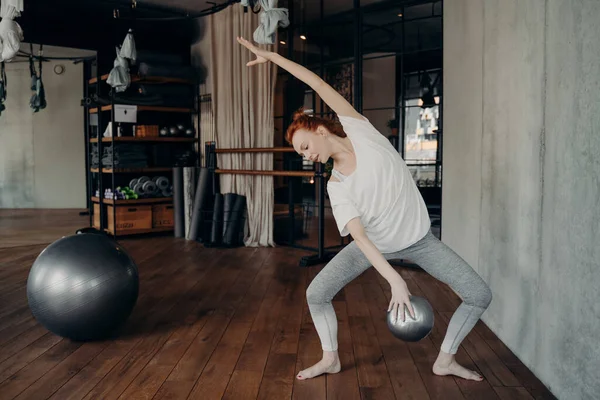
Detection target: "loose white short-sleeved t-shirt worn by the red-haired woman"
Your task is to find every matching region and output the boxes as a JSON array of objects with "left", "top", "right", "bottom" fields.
[{"left": 327, "top": 116, "right": 431, "bottom": 253}]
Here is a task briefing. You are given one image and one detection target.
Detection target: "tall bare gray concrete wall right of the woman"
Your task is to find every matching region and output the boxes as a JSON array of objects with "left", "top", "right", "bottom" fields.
[{"left": 442, "top": 0, "right": 600, "bottom": 399}]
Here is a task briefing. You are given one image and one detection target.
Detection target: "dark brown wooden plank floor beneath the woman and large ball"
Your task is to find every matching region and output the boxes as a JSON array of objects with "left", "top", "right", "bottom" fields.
[{"left": 0, "top": 211, "right": 554, "bottom": 400}]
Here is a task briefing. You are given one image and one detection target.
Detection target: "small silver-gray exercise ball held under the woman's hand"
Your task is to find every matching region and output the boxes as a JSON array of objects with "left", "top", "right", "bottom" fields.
[{"left": 387, "top": 296, "right": 434, "bottom": 342}]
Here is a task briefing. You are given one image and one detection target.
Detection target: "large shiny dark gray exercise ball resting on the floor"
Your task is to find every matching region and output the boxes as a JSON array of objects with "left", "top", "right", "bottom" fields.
[{"left": 27, "top": 233, "right": 139, "bottom": 341}]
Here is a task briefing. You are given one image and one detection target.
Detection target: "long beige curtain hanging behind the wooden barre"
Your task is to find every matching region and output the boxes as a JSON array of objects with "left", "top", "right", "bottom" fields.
[{"left": 209, "top": 4, "right": 277, "bottom": 247}]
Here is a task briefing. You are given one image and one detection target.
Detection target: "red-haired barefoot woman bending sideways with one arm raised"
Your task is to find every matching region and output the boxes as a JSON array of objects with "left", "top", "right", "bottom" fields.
[{"left": 238, "top": 38, "right": 492, "bottom": 381}]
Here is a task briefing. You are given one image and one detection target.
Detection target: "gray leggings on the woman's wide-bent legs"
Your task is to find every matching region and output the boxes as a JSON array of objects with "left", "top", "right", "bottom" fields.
[{"left": 306, "top": 231, "right": 492, "bottom": 354}]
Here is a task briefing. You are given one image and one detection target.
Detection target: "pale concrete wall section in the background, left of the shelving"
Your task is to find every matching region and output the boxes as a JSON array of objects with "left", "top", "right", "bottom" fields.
[{"left": 0, "top": 48, "right": 86, "bottom": 208}]
